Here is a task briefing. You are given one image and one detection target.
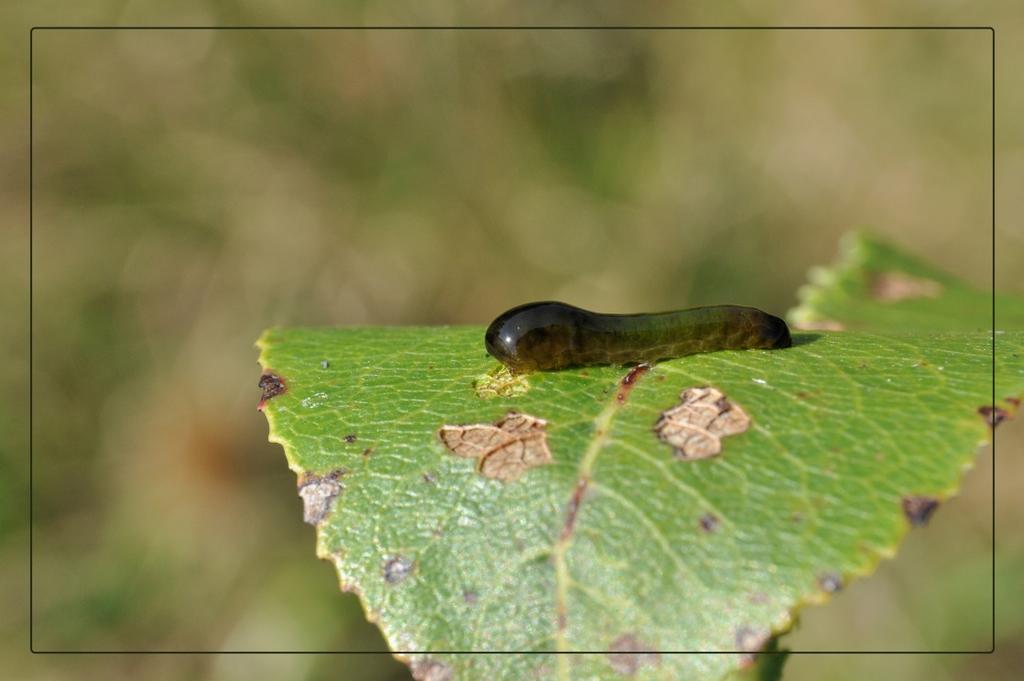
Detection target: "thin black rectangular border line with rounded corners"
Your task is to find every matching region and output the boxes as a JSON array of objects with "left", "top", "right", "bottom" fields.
[{"left": 29, "top": 25, "right": 997, "bottom": 661}]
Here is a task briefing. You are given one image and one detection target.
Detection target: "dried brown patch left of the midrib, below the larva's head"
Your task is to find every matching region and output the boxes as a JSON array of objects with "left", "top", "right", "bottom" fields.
[{"left": 437, "top": 412, "right": 551, "bottom": 482}]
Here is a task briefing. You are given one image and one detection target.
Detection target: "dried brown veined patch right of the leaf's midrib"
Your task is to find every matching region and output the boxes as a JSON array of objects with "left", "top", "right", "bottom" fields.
[{"left": 654, "top": 387, "right": 751, "bottom": 461}]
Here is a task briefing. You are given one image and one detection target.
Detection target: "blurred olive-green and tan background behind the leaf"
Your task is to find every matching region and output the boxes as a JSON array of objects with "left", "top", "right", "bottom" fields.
[{"left": 0, "top": 2, "right": 1024, "bottom": 680}]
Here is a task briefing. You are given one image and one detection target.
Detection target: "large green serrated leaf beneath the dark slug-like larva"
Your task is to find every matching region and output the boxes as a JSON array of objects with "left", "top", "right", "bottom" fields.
[{"left": 259, "top": 235, "right": 1024, "bottom": 679}]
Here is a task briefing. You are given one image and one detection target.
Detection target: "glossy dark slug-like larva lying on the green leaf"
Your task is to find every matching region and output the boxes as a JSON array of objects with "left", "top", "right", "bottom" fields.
[{"left": 483, "top": 301, "right": 793, "bottom": 372}]
